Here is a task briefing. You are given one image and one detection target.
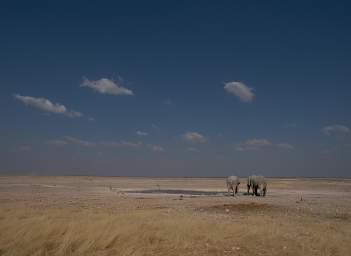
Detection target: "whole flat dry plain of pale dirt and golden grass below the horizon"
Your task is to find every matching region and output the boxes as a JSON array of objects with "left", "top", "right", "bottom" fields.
[{"left": 0, "top": 176, "right": 351, "bottom": 256}]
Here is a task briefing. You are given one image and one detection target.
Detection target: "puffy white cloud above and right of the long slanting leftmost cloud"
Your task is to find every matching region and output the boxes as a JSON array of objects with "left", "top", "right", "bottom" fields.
[{"left": 80, "top": 78, "right": 134, "bottom": 96}]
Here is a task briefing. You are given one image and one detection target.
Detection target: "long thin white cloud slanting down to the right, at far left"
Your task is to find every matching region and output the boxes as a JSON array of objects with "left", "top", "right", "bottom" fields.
[{"left": 14, "top": 94, "right": 83, "bottom": 117}]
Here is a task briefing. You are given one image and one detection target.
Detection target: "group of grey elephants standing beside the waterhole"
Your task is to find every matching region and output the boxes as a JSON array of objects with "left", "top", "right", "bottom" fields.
[{"left": 227, "top": 175, "right": 267, "bottom": 196}]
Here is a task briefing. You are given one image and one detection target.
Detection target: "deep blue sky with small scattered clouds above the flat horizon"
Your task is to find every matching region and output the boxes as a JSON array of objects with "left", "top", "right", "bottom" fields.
[{"left": 0, "top": 1, "right": 351, "bottom": 177}]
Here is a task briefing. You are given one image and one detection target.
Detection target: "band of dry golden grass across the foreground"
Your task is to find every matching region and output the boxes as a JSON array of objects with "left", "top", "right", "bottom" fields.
[{"left": 0, "top": 203, "right": 351, "bottom": 255}]
